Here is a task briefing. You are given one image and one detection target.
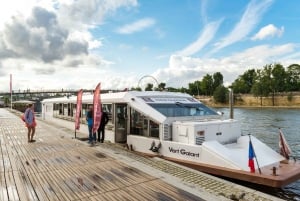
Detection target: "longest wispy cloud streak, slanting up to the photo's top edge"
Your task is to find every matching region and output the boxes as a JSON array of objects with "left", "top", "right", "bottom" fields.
[{"left": 211, "top": 0, "right": 273, "bottom": 53}]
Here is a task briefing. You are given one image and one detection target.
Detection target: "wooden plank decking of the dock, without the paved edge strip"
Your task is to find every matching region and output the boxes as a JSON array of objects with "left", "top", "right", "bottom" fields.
[{"left": 0, "top": 109, "right": 203, "bottom": 201}]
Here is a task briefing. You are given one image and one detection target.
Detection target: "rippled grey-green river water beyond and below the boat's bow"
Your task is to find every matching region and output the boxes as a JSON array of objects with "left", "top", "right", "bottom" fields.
[{"left": 215, "top": 108, "right": 300, "bottom": 201}]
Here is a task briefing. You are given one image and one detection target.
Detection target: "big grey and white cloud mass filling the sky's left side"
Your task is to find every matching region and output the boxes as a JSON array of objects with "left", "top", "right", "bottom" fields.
[{"left": 0, "top": 0, "right": 138, "bottom": 90}]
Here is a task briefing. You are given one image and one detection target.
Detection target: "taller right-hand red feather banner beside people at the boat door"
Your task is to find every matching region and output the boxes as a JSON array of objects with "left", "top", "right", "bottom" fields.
[{"left": 93, "top": 83, "right": 102, "bottom": 133}]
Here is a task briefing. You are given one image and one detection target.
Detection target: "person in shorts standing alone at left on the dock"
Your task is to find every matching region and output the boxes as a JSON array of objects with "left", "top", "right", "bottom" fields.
[{"left": 24, "top": 103, "right": 36, "bottom": 142}]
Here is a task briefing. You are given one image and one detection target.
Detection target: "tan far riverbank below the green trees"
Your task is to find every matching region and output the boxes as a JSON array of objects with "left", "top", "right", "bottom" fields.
[{"left": 196, "top": 93, "right": 300, "bottom": 109}]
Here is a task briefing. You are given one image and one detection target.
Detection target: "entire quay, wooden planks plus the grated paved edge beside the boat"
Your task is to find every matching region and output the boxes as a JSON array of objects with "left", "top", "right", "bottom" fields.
[{"left": 0, "top": 109, "right": 280, "bottom": 201}]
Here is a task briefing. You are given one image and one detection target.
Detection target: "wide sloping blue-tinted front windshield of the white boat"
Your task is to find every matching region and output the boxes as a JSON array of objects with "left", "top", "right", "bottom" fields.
[{"left": 148, "top": 102, "right": 218, "bottom": 117}]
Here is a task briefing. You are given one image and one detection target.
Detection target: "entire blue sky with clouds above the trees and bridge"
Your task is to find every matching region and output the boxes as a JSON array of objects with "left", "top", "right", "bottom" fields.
[{"left": 0, "top": 0, "right": 300, "bottom": 92}]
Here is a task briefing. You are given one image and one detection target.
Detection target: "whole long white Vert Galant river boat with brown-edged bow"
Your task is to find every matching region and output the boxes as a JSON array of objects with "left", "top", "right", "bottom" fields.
[{"left": 42, "top": 91, "right": 300, "bottom": 188}]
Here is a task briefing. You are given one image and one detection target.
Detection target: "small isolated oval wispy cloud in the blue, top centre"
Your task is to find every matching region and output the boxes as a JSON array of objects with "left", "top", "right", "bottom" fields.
[{"left": 117, "top": 18, "right": 155, "bottom": 34}]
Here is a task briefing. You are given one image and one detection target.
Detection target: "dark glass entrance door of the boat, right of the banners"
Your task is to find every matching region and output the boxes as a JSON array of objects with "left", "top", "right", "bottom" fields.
[{"left": 115, "top": 103, "right": 127, "bottom": 143}]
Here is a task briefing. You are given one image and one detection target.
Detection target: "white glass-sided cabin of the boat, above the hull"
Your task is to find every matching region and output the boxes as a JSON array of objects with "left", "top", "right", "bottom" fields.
[{"left": 42, "top": 91, "right": 240, "bottom": 145}]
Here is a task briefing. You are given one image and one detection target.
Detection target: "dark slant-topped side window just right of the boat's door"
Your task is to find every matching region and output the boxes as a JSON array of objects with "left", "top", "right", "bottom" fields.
[{"left": 130, "top": 108, "right": 159, "bottom": 138}]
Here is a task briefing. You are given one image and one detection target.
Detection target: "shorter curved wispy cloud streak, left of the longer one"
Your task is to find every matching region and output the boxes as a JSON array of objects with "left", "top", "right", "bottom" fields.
[{"left": 176, "top": 20, "right": 222, "bottom": 56}]
